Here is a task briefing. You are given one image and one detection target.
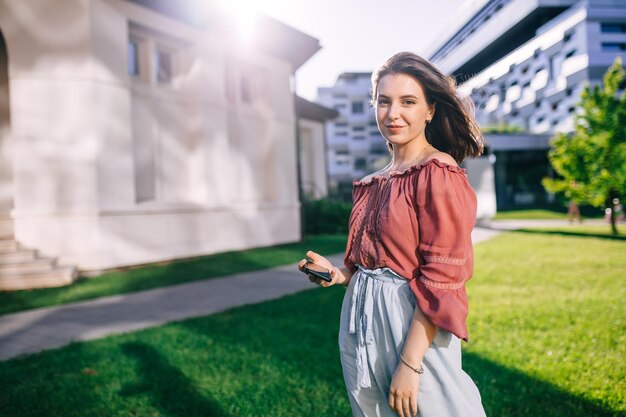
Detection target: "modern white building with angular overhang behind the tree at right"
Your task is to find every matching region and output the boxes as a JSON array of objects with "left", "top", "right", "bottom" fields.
[{"left": 430, "top": 0, "right": 626, "bottom": 209}]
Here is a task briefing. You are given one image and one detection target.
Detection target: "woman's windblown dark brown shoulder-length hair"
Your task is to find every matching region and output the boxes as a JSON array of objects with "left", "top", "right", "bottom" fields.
[{"left": 371, "top": 52, "right": 485, "bottom": 163}]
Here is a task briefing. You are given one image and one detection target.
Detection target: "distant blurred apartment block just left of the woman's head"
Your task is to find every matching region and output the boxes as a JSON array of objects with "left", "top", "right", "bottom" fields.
[{"left": 317, "top": 72, "right": 390, "bottom": 200}]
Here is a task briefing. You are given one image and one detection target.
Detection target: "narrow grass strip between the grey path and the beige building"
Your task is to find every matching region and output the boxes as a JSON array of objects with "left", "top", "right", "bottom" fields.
[{"left": 0, "top": 235, "right": 346, "bottom": 314}]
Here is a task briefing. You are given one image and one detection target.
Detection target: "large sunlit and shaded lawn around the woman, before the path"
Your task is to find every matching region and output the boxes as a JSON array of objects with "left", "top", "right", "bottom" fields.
[{"left": 0, "top": 227, "right": 626, "bottom": 417}]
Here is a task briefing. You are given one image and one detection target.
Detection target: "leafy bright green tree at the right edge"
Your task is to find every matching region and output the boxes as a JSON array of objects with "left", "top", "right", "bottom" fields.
[{"left": 542, "top": 57, "right": 626, "bottom": 234}]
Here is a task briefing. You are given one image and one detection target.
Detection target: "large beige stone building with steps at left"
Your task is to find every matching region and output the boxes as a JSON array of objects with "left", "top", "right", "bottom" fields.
[{"left": 0, "top": 0, "right": 320, "bottom": 289}]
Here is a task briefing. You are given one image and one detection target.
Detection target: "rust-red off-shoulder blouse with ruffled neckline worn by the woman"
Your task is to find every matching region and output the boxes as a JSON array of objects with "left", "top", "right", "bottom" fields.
[{"left": 344, "top": 159, "right": 476, "bottom": 341}]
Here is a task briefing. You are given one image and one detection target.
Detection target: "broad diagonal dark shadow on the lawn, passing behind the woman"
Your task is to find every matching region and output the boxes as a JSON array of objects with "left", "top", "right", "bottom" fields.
[{"left": 172, "top": 289, "right": 618, "bottom": 417}]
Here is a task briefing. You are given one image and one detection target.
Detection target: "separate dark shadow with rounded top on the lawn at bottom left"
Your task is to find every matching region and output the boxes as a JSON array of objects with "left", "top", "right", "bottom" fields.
[{"left": 120, "top": 342, "right": 230, "bottom": 417}]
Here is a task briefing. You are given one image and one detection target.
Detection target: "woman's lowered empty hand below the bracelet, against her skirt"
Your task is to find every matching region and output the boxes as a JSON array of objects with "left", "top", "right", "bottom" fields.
[{"left": 389, "top": 362, "right": 422, "bottom": 417}]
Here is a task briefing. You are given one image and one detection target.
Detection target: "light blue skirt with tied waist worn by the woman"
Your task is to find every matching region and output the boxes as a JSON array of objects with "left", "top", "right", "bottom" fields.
[{"left": 339, "top": 265, "right": 485, "bottom": 417}]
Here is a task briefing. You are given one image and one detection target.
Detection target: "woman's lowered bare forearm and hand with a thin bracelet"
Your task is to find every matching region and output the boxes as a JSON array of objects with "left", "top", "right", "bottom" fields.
[{"left": 389, "top": 306, "right": 437, "bottom": 417}]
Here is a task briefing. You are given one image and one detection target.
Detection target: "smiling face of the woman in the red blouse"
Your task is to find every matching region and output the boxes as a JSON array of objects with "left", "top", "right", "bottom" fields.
[{"left": 376, "top": 74, "right": 435, "bottom": 145}]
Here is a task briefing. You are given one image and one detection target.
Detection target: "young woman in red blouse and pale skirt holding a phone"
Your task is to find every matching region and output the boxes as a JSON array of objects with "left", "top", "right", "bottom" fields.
[{"left": 299, "top": 52, "right": 485, "bottom": 417}]
